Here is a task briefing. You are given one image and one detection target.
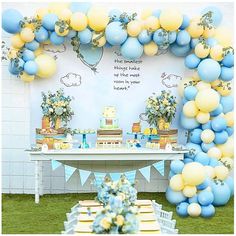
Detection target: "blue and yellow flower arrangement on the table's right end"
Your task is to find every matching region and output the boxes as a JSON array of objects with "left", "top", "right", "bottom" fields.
[{"left": 146, "top": 90, "right": 177, "bottom": 127}]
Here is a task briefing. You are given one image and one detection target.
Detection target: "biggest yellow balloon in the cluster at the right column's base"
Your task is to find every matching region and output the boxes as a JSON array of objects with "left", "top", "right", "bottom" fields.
[{"left": 182, "top": 162, "right": 206, "bottom": 186}]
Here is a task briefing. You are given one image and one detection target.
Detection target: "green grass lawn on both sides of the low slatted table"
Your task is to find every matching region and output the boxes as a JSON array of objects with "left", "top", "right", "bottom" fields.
[{"left": 2, "top": 193, "right": 234, "bottom": 234}]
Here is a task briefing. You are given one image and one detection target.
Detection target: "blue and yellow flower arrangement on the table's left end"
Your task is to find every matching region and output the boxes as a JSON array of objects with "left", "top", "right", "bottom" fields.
[{"left": 41, "top": 89, "right": 74, "bottom": 126}]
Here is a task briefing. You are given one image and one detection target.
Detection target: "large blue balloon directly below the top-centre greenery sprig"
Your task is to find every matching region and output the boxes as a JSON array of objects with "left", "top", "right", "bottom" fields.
[{"left": 105, "top": 21, "right": 127, "bottom": 47}]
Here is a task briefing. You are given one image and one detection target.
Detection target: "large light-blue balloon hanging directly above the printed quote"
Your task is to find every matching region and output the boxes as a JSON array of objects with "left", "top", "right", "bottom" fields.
[{"left": 120, "top": 37, "right": 143, "bottom": 60}]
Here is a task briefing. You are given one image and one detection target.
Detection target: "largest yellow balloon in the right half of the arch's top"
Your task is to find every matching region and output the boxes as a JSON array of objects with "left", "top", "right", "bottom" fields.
[{"left": 160, "top": 8, "right": 183, "bottom": 31}]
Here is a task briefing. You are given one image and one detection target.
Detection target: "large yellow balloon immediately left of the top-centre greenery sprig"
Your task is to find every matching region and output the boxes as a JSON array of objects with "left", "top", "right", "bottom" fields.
[{"left": 87, "top": 6, "right": 109, "bottom": 31}]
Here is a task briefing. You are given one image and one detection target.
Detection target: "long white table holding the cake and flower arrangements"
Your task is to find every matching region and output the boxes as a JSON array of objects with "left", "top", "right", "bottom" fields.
[{"left": 28, "top": 148, "right": 188, "bottom": 203}]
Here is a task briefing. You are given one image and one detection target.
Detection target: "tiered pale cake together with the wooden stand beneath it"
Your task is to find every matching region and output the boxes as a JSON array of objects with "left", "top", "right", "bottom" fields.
[{"left": 96, "top": 106, "right": 123, "bottom": 147}]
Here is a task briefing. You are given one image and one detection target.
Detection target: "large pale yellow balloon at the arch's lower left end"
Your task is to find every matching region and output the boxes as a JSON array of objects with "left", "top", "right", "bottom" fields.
[{"left": 35, "top": 54, "right": 56, "bottom": 78}]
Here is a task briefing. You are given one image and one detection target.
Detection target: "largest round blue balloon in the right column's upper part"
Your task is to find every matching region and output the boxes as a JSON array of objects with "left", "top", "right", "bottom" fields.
[{"left": 197, "top": 58, "right": 221, "bottom": 83}]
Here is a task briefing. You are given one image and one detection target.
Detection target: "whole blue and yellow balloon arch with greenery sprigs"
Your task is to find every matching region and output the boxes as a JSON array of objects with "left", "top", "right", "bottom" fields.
[{"left": 2, "top": 3, "right": 234, "bottom": 217}]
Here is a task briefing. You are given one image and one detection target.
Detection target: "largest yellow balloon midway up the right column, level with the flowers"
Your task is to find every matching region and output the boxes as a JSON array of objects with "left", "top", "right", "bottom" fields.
[{"left": 195, "top": 89, "right": 220, "bottom": 112}]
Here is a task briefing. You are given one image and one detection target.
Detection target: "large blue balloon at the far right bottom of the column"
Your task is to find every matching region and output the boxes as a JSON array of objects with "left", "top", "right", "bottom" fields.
[{"left": 211, "top": 180, "right": 230, "bottom": 206}]
